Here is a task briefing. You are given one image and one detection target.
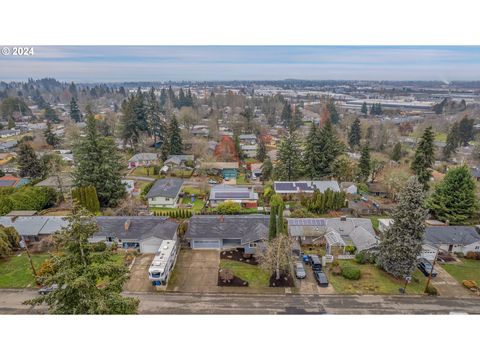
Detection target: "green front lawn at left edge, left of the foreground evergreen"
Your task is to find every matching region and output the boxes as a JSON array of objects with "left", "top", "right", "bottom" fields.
[{"left": 0, "top": 253, "right": 49, "bottom": 288}]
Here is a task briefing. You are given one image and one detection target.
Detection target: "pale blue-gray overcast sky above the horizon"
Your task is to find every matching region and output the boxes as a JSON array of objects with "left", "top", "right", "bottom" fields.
[{"left": 0, "top": 46, "right": 480, "bottom": 82}]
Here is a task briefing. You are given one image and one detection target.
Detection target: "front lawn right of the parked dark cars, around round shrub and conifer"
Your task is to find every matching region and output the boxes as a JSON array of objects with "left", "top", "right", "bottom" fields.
[{"left": 327, "top": 260, "right": 426, "bottom": 294}]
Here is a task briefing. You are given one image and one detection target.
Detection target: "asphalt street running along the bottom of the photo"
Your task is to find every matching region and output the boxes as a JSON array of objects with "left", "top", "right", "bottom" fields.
[{"left": 0, "top": 289, "right": 480, "bottom": 314}]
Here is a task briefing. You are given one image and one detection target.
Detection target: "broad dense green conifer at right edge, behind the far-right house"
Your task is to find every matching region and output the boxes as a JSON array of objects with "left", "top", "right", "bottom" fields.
[{"left": 428, "top": 165, "right": 479, "bottom": 224}]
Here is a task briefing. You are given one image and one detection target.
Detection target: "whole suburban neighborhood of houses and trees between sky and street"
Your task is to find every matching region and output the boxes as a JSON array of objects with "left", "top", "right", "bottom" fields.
[{"left": 0, "top": 46, "right": 480, "bottom": 320}]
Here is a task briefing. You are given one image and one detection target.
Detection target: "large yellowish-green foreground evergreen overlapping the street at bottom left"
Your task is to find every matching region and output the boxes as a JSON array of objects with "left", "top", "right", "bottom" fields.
[{"left": 27, "top": 209, "right": 139, "bottom": 315}]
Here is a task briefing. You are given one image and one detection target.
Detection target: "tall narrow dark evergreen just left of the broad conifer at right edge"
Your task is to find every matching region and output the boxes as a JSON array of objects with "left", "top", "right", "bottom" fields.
[{"left": 412, "top": 126, "right": 435, "bottom": 190}]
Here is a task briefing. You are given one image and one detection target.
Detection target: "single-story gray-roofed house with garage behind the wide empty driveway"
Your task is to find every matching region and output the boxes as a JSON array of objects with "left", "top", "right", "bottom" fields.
[{"left": 185, "top": 215, "right": 270, "bottom": 254}]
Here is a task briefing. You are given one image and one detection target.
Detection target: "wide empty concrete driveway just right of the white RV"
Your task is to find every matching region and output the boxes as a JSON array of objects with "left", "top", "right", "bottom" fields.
[{"left": 167, "top": 249, "right": 220, "bottom": 293}]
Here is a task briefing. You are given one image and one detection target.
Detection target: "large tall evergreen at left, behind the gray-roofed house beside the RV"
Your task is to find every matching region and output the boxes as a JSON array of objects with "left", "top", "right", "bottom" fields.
[{"left": 73, "top": 115, "right": 125, "bottom": 207}]
